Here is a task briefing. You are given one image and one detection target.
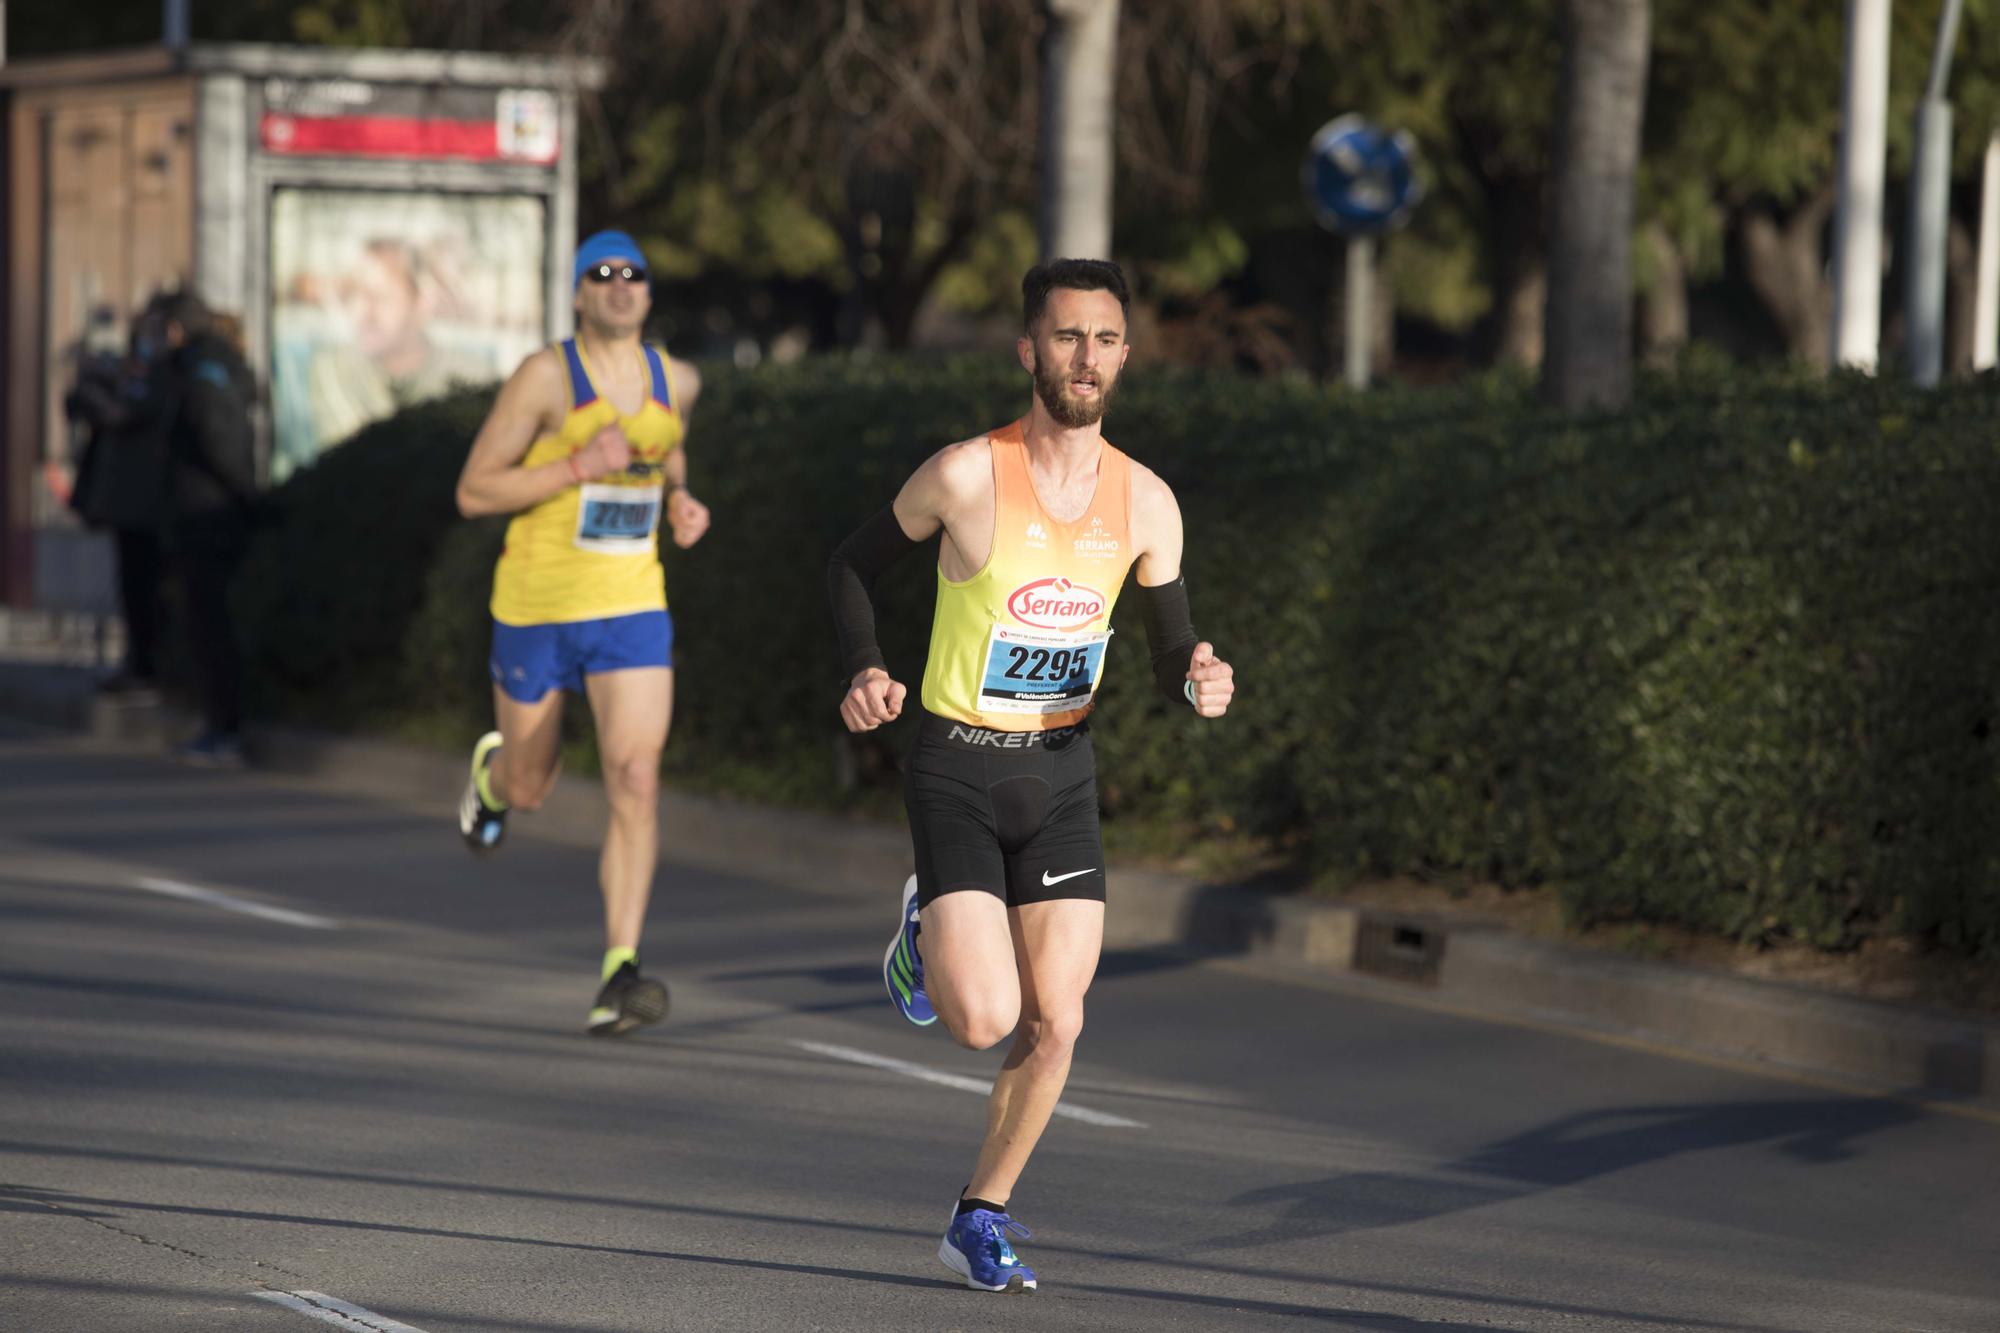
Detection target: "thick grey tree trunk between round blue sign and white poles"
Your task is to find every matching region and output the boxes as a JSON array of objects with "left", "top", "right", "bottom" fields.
[{"left": 1542, "top": 0, "right": 1652, "bottom": 410}]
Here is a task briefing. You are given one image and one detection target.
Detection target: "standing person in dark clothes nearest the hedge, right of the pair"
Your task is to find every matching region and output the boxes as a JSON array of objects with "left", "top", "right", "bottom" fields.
[{"left": 140, "top": 290, "right": 258, "bottom": 767}]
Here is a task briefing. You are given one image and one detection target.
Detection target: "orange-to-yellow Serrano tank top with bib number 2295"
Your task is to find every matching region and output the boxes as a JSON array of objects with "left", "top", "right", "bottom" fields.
[{"left": 924, "top": 422, "right": 1134, "bottom": 731}]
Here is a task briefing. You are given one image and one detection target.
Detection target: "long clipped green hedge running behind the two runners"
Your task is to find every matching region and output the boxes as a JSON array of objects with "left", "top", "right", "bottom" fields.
[{"left": 244, "top": 360, "right": 2000, "bottom": 957}]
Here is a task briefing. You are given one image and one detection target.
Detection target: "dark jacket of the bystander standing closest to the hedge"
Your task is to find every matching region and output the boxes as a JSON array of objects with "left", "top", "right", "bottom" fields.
[{"left": 160, "top": 336, "right": 258, "bottom": 542}]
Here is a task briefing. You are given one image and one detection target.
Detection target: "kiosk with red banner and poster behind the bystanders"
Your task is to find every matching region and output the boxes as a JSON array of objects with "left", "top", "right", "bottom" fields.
[{"left": 0, "top": 44, "right": 602, "bottom": 610}]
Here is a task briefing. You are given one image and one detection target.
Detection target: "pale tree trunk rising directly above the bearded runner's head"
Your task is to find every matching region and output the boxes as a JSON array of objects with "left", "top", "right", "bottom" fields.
[{"left": 1042, "top": 0, "right": 1118, "bottom": 260}]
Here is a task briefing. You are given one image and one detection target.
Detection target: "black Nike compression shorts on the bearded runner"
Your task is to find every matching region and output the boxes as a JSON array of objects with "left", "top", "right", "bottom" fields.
[{"left": 904, "top": 713, "right": 1104, "bottom": 907}]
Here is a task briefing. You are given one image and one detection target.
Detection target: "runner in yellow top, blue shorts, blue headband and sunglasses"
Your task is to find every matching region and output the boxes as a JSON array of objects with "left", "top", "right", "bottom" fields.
[{"left": 458, "top": 232, "right": 708, "bottom": 1037}]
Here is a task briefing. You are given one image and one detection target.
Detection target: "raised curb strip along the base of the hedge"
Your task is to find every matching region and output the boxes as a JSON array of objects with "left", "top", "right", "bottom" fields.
[{"left": 0, "top": 660, "right": 2000, "bottom": 1115}]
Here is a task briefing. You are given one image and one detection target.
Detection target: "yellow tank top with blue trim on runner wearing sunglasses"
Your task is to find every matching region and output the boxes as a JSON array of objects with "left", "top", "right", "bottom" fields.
[{"left": 492, "top": 338, "right": 682, "bottom": 624}]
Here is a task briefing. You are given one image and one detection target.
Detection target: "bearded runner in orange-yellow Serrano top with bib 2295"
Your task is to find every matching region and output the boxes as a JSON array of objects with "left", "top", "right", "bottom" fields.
[{"left": 828, "top": 260, "right": 1236, "bottom": 1291}]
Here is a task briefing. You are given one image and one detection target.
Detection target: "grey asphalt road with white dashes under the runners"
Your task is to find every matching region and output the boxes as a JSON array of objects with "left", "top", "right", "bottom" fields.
[{"left": 0, "top": 733, "right": 2000, "bottom": 1333}]
